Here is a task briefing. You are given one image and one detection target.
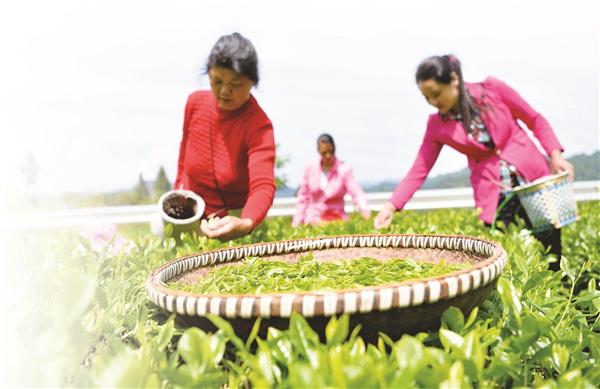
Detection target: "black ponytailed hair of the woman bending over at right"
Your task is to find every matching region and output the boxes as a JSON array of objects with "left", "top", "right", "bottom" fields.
[{"left": 416, "top": 54, "right": 485, "bottom": 130}]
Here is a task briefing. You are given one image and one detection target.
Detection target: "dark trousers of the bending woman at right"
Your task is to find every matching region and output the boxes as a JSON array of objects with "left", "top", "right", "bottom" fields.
[{"left": 485, "top": 195, "right": 562, "bottom": 271}]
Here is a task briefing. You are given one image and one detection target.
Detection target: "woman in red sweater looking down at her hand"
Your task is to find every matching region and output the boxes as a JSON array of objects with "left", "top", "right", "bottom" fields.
[{"left": 174, "top": 33, "right": 275, "bottom": 242}]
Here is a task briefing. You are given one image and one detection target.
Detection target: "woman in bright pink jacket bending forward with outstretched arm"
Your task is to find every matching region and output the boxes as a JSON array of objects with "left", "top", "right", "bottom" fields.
[{"left": 374, "top": 55, "right": 573, "bottom": 270}]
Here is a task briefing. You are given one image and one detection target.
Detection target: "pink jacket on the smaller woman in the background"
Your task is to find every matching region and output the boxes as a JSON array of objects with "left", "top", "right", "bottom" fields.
[{"left": 292, "top": 158, "right": 369, "bottom": 227}]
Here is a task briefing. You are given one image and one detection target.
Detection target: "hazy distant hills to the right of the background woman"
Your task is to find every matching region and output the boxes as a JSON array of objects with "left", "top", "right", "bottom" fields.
[{"left": 363, "top": 151, "right": 600, "bottom": 192}]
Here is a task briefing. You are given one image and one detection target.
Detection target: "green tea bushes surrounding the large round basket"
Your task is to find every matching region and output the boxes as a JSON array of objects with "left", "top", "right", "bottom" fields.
[{"left": 2, "top": 201, "right": 600, "bottom": 388}]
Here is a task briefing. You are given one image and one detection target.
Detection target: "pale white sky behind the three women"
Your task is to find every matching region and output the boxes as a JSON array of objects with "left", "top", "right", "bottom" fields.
[{"left": 0, "top": 1, "right": 600, "bottom": 199}]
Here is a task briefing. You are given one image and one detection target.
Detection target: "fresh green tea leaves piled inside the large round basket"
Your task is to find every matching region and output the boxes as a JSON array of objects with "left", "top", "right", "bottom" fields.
[{"left": 168, "top": 253, "right": 472, "bottom": 294}]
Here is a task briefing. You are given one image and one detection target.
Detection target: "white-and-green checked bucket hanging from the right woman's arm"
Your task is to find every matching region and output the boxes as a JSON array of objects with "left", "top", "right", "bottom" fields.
[{"left": 512, "top": 171, "right": 580, "bottom": 232}]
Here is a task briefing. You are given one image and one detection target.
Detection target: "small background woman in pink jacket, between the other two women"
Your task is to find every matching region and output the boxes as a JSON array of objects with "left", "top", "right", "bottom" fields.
[{"left": 292, "top": 134, "right": 371, "bottom": 227}]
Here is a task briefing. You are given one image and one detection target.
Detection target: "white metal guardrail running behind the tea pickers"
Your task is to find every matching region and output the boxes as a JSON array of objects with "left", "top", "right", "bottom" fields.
[{"left": 0, "top": 181, "right": 600, "bottom": 231}]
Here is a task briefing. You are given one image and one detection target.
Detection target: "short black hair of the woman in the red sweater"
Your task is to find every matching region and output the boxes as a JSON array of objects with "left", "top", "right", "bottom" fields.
[{"left": 206, "top": 32, "right": 259, "bottom": 86}]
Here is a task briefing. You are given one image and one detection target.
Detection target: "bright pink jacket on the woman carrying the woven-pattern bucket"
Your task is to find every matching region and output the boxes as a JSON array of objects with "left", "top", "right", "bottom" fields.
[{"left": 389, "top": 77, "right": 563, "bottom": 224}]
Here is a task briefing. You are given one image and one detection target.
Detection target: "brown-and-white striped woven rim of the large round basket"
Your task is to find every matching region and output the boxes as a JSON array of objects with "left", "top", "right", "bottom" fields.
[{"left": 146, "top": 234, "right": 507, "bottom": 317}]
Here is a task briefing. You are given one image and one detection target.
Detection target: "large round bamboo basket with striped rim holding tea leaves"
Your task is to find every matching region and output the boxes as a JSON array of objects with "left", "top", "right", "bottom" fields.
[{"left": 146, "top": 235, "right": 507, "bottom": 341}]
